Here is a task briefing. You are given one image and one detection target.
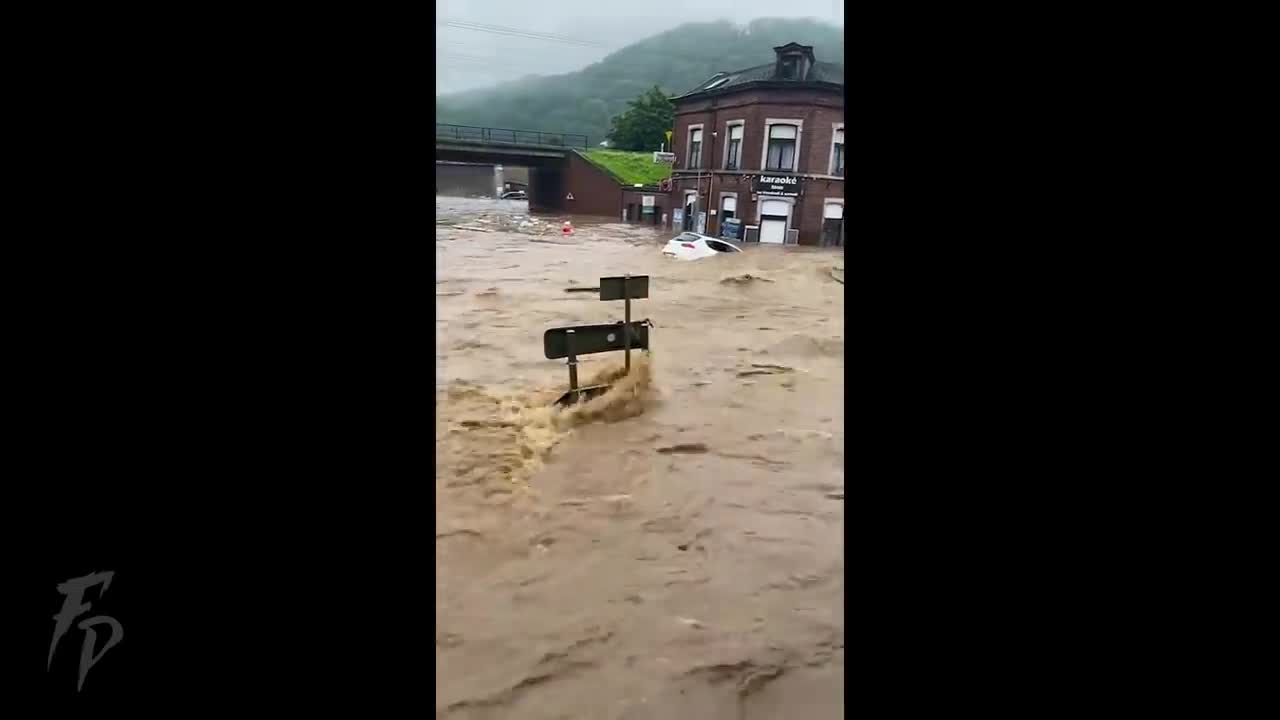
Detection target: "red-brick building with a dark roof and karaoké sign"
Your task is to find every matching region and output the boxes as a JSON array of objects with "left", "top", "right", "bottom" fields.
[{"left": 669, "top": 42, "right": 845, "bottom": 245}]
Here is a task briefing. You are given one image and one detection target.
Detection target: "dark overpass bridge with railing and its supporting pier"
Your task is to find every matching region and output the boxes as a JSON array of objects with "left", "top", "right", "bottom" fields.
[{"left": 435, "top": 124, "right": 588, "bottom": 213}]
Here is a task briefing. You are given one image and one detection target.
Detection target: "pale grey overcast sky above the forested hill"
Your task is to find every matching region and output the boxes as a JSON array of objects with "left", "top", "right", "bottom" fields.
[{"left": 435, "top": 0, "right": 845, "bottom": 95}]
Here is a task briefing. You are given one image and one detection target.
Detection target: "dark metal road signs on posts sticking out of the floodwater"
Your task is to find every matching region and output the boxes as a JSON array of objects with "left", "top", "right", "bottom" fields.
[{"left": 543, "top": 275, "right": 653, "bottom": 405}]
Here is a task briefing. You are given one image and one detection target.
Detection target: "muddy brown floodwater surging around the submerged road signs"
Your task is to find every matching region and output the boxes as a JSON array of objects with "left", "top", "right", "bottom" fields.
[{"left": 435, "top": 197, "right": 845, "bottom": 720}]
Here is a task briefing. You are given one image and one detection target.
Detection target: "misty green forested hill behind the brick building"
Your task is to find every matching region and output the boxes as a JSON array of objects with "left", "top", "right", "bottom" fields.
[{"left": 435, "top": 18, "right": 845, "bottom": 145}]
